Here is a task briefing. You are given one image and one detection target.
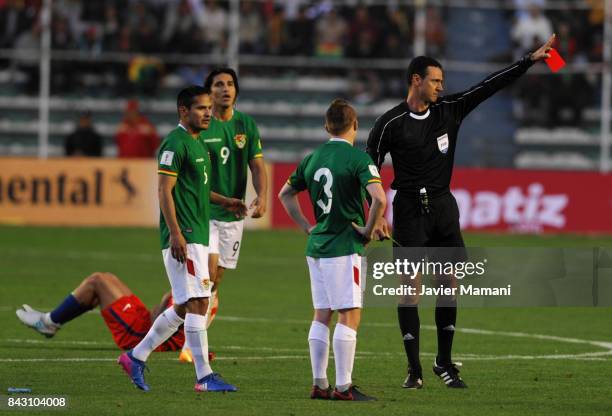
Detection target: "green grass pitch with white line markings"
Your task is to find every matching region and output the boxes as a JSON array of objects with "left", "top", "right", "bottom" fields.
[{"left": 0, "top": 227, "right": 612, "bottom": 416}]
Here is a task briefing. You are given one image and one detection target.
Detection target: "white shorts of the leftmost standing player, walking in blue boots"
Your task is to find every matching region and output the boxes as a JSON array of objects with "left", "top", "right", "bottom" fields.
[{"left": 162, "top": 244, "right": 212, "bottom": 305}]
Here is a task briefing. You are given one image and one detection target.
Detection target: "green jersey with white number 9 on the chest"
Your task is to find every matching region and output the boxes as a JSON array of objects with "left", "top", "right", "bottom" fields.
[{"left": 200, "top": 110, "right": 263, "bottom": 221}]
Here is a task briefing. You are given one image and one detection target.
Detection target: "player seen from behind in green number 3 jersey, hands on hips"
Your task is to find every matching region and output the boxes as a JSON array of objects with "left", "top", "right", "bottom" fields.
[{"left": 278, "top": 100, "right": 387, "bottom": 400}]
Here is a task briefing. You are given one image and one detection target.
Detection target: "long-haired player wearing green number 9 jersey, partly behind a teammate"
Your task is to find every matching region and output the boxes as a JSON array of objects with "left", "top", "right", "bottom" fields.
[{"left": 201, "top": 68, "right": 267, "bottom": 325}]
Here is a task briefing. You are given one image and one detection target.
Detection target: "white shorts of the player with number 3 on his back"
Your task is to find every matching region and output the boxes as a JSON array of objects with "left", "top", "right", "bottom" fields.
[{"left": 306, "top": 254, "right": 365, "bottom": 311}]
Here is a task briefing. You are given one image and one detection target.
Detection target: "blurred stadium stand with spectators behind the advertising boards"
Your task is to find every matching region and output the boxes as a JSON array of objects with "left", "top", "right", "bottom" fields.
[{"left": 0, "top": 0, "right": 603, "bottom": 169}]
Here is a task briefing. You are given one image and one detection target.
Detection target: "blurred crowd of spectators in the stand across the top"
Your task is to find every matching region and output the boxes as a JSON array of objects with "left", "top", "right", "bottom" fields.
[{"left": 0, "top": 0, "right": 604, "bottom": 121}]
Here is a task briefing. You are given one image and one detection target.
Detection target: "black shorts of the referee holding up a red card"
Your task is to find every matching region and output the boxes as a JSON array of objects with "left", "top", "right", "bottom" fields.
[{"left": 393, "top": 191, "right": 467, "bottom": 261}]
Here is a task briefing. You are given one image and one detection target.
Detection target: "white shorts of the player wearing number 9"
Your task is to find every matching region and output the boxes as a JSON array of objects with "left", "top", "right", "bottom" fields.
[{"left": 208, "top": 220, "right": 244, "bottom": 269}]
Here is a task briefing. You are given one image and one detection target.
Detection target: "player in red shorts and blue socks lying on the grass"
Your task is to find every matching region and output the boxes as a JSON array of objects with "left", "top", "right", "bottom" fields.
[{"left": 16, "top": 272, "right": 185, "bottom": 351}]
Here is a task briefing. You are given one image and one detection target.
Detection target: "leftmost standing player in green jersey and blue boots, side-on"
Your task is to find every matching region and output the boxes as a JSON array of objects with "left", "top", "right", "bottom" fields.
[{"left": 118, "top": 86, "right": 246, "bottom": 392}]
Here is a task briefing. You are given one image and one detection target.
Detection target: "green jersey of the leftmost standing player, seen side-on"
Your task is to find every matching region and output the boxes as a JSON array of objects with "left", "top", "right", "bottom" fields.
[{"left": 157, "top": 125, "right": 211, "bottom": 249}]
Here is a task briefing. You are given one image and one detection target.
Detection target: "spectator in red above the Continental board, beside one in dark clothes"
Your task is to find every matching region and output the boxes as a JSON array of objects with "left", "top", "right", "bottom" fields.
[{"left": 115, "top": 100, "right": 159, "bottom": 158}]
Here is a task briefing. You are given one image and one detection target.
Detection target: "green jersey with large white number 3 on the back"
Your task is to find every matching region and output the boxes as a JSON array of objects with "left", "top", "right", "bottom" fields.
[{"left": 287, "top": 138, "right": 381, "bottom": 258}]
